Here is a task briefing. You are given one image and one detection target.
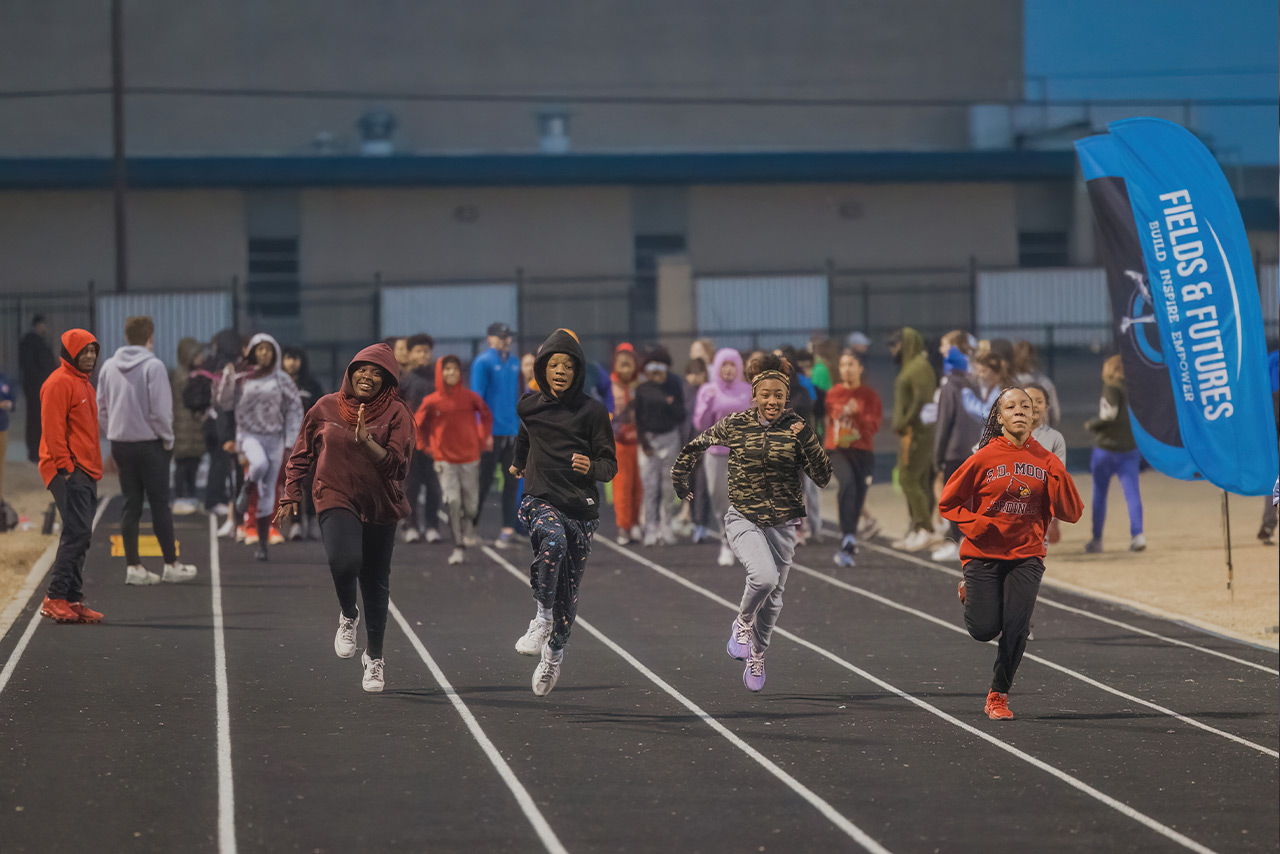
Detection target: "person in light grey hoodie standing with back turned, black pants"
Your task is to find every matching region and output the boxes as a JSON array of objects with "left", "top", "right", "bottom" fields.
[{"left": 97, "top": 316, "right": 196, "bottom": 585}]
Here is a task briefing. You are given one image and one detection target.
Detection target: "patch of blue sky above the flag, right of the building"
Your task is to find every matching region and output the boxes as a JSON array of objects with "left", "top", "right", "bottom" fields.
[{"left": 1024, "top": 0, "right": 1280, "bottom": 165}]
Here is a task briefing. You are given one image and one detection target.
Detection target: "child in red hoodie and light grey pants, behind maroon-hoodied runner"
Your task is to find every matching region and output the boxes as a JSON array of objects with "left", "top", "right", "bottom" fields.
[{"left": 415, "top": 355, "right": 493, "bottom": 566}]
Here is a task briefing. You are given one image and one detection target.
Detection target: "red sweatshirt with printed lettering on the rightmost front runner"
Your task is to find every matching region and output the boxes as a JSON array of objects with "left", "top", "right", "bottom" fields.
[{"left": 938, "top": 437, "right": 1084, "bottom": 561}]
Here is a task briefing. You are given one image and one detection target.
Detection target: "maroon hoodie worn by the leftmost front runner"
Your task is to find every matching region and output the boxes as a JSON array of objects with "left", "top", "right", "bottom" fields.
[{"left": 282, "top": 344, "right": 413, "bottom": 525}]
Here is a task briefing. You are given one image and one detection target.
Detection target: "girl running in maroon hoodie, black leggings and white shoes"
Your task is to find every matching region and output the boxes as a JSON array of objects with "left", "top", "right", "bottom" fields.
[{"left": 275, "top": 344, "right": 413, "bottom": 693}]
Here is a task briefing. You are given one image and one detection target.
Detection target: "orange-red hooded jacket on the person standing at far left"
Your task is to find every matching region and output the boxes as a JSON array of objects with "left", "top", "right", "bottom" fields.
[{"left": 40, "top": 329, "right": 102, "bottom": 487}]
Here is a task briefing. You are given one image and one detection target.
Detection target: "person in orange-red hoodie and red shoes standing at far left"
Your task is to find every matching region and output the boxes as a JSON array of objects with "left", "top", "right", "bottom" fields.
[{"left": 40, "top": 329, "right": 102, "bottom": 622}]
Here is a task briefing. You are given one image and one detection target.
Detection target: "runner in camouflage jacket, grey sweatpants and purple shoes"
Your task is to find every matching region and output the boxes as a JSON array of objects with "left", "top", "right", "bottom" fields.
[{"left": 671, "top": 353, "right": 831, "bottom": 691}]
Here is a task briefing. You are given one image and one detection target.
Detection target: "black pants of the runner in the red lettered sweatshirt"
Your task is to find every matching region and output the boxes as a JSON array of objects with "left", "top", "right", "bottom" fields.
[{"left": 964, "top": 557, "right": 1044, "bottom": 694}]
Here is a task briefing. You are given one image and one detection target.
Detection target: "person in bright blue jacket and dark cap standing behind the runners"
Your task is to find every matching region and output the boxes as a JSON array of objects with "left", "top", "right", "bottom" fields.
[{"left": 471, "top": 323, "right": 522, "bottom": 548}]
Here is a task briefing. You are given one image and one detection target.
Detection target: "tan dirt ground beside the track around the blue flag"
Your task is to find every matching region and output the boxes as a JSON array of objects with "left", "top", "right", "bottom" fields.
[{"left": 823, "top": 471, "right": 1280, "bottom": 647}]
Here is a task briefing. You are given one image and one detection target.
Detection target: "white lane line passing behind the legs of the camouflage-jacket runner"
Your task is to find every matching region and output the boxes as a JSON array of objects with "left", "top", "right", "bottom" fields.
[{"left": 596, "top": 538, "right": 1213, "bottom": 854}]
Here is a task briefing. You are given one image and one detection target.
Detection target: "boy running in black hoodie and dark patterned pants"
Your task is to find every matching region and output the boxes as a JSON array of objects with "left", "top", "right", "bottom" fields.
[{"left": 511, "top": 329, "right": 618, "bottom": 697}]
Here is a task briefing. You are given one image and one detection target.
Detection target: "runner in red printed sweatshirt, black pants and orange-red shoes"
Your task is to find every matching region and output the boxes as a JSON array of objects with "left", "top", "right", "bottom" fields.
[{"left": 938, "top": 387, "right": 1084, "bottom": 721}]
